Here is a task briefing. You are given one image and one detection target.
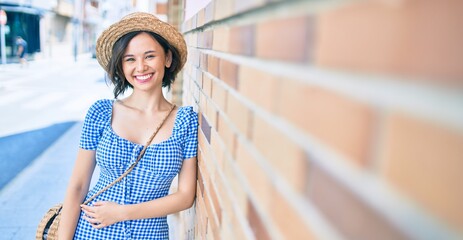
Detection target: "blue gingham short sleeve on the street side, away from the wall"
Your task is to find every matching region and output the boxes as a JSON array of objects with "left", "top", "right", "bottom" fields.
[{"left": 79, "top": 99, "right": 112, "bottom": 150}]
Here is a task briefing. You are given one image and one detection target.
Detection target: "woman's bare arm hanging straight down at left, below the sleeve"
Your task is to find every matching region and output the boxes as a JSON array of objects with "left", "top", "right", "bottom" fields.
[{"left": 58, "top": 148, "right": 95, "bottom": 240}]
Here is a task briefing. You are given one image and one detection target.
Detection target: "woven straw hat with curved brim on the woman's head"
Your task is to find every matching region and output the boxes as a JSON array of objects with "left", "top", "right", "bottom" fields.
[{"left": 96, "top": 12, "right": 187, "bottom": 73}]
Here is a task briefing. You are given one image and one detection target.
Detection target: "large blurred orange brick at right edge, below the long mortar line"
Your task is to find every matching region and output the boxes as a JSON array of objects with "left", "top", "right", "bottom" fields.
[{"left": 383, "top": 113, "right": 463, "bottom": 229}]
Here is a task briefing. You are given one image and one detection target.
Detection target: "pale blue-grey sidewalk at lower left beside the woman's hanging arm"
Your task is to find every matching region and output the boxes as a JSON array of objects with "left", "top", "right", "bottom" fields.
[{"left": 0, "top": 123, "right": 82, "bottom": 240}]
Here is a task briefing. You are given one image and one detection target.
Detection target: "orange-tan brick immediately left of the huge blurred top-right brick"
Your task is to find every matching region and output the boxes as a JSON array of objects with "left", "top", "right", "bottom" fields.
[{"left": 255, "top": 17, "right": 312, "bottom": 62}]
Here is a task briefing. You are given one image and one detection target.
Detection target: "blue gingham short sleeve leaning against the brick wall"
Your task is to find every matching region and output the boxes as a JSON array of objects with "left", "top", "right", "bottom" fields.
[{"left": 183, "top": 107, "right": 199, "bottom": 159}]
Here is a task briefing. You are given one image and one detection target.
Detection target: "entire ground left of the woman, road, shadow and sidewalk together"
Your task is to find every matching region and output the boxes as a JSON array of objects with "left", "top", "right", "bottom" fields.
[{"left": 0, "top": 56, "right": 112, "bottom": 239}]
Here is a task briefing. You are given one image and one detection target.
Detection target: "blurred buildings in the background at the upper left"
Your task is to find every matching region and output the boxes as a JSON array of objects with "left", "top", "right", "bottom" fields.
[{"left": 0, "top": 0, "right": 167, "bottom": 61}]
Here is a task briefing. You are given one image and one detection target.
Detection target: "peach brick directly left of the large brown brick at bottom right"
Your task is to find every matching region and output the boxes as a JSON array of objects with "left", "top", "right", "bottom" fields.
[{"left": 252, "top": 115, "right": 307, "bottom": 191}]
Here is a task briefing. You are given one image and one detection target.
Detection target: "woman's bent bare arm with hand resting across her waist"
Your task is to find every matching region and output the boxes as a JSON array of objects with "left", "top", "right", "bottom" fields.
[{"left": 82, "top": 157, "right": 196, "bottom": 228}]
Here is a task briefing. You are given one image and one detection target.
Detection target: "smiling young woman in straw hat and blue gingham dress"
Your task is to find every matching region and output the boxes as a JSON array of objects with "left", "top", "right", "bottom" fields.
[{"left": 58, "top": 13, "right": 198, "bottom": 240}]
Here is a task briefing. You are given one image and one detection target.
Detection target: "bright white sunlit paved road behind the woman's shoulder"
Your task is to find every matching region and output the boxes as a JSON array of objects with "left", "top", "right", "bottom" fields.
[{"left": 0, "top": 54, "right": 112, "bottom": 137}]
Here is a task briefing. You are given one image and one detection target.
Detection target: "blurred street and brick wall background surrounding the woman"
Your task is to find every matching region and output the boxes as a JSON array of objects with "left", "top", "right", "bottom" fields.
[{"left": 0, "top": 0, "right": 463, "bottom": 240}]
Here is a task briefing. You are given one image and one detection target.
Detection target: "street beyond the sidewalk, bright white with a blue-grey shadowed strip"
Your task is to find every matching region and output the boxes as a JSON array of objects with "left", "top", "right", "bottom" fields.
[{"left": 0, "top": 56, "right": 112, "bottom": 189}]
